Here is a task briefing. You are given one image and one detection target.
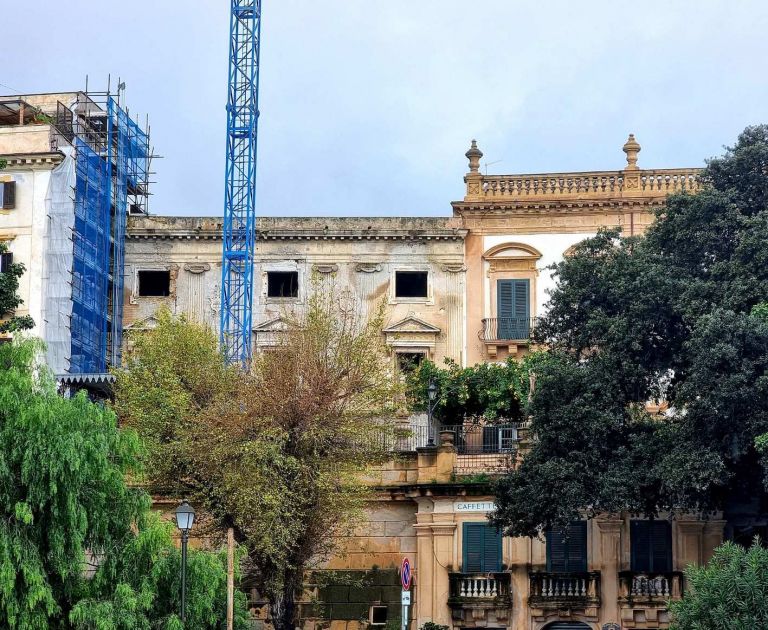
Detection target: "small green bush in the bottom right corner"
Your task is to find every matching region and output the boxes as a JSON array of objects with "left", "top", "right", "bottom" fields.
[{"left": 670, "top": 540, "right": 768, "bottom": 630}]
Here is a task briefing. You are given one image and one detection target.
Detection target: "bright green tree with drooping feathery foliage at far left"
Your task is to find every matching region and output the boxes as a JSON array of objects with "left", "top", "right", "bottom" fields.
[{"left": 0, "top": 340, "right": 244, "bottom": 630}]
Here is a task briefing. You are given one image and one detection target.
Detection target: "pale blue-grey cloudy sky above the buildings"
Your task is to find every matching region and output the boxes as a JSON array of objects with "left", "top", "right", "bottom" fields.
[{"left": 0, "top": 0, "right": 768, "bottom": 216}]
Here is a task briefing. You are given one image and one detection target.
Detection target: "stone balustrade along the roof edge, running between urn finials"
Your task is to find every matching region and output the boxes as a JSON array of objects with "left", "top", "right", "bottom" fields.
[{"left": 475, "top": 169, "right": 700, "bottom": 199}]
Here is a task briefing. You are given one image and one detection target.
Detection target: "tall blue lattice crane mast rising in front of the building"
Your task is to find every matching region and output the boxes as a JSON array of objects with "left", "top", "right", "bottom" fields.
[{"left": 220, "top": 0, "right": 261, "bottom": 367}]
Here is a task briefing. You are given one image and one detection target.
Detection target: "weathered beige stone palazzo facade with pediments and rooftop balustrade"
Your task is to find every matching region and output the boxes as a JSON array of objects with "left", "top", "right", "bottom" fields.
[{"left": 125, "top": 136, "right": 712, "bottom": 630}]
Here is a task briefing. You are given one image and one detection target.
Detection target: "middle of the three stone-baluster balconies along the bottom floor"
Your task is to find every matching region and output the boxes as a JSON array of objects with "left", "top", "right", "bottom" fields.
[{"left": 529, "top": 571, "right": 600, "bottom": 609}]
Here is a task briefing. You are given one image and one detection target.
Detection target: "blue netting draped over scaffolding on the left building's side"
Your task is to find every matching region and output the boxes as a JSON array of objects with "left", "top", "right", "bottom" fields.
[{"left": 69, "top": 96, "right": 150, "bottom": 374}]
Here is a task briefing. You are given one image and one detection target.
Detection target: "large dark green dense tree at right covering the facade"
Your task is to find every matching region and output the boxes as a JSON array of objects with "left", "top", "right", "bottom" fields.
[{"left": 496, "top": 126, "right": 768, "bottom": 535}]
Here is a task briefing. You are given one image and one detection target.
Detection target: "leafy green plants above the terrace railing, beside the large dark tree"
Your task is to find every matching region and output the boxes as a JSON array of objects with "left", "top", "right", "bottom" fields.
[{"left": 406, "top": 353, "right": 547, "bottom": 424}]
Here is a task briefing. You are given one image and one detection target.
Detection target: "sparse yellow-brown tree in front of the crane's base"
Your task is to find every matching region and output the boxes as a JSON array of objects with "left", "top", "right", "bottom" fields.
[{"left": 115, "top": 282, "right": 397, "bottom": 630}]
